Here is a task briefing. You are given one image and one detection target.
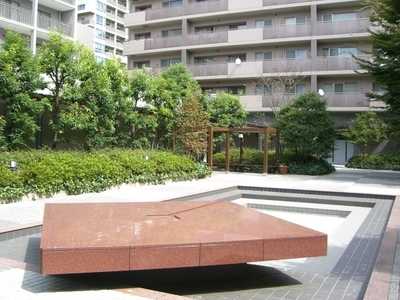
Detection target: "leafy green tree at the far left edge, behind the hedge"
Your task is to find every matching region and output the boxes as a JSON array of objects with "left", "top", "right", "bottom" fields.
[{"left": 0, "top": 31, "right": 46, "bottom": 150}]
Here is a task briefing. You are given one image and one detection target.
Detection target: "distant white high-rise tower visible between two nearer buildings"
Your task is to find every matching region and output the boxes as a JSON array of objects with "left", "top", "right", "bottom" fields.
[{"left": 77, "top": 0, "right": 129, "bottom": 64}]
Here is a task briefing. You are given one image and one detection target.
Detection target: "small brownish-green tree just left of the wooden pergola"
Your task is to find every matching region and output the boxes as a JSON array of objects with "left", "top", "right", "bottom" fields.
[{"left": 176, "top": 96, "right": 208, "bottom": 159}]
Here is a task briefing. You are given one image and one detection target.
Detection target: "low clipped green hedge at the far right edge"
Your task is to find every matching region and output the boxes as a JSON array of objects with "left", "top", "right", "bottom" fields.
[{"left": 346, "top": 154, "right": 400, "bottom": 171}]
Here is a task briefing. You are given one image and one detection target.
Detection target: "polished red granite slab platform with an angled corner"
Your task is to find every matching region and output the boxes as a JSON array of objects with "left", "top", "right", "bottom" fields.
[{"left": 40, "top": 201, "right": 327, "bottom": 275}]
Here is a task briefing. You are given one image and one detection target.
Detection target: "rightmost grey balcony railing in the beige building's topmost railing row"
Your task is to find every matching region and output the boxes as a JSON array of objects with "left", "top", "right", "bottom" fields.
[{"left": 317, "top": 19, "right": 370, "bottom": 35}]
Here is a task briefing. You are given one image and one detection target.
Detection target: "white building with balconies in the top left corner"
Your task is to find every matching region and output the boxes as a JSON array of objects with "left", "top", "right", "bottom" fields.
[{"left": 0, "top": 0, "right": 76, "bottom": 53}]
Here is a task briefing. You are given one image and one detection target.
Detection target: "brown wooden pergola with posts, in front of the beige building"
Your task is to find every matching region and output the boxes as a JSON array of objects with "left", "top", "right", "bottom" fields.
[{"left": 207, "top": 126, "right": 279, "bottom": 173}]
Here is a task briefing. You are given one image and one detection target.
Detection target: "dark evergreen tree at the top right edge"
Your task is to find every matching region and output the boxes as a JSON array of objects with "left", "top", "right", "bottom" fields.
[{"left": 357, "top": 0, "right": 400, "bottom": 116}]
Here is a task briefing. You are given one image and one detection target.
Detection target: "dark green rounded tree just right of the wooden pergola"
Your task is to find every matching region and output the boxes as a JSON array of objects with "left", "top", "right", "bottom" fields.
[{"left": 277, "top": 92, "right": 336, "bottom": 162}]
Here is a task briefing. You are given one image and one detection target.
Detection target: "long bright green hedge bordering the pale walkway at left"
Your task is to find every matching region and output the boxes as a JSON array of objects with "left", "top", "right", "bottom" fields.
[{"left": 0, "top": 149, "right": 211, "bottom": 202}]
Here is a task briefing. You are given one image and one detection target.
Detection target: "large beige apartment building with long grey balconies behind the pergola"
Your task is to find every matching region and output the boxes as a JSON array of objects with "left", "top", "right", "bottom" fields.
[{"left": 123, "top": 0, "right": 378, "bottom": 163}]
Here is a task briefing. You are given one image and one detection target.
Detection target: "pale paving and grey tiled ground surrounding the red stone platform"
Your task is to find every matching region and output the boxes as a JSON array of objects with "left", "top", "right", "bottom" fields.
[{"left": 0, "top": 168, "right": 400, "bottom": 300}]
